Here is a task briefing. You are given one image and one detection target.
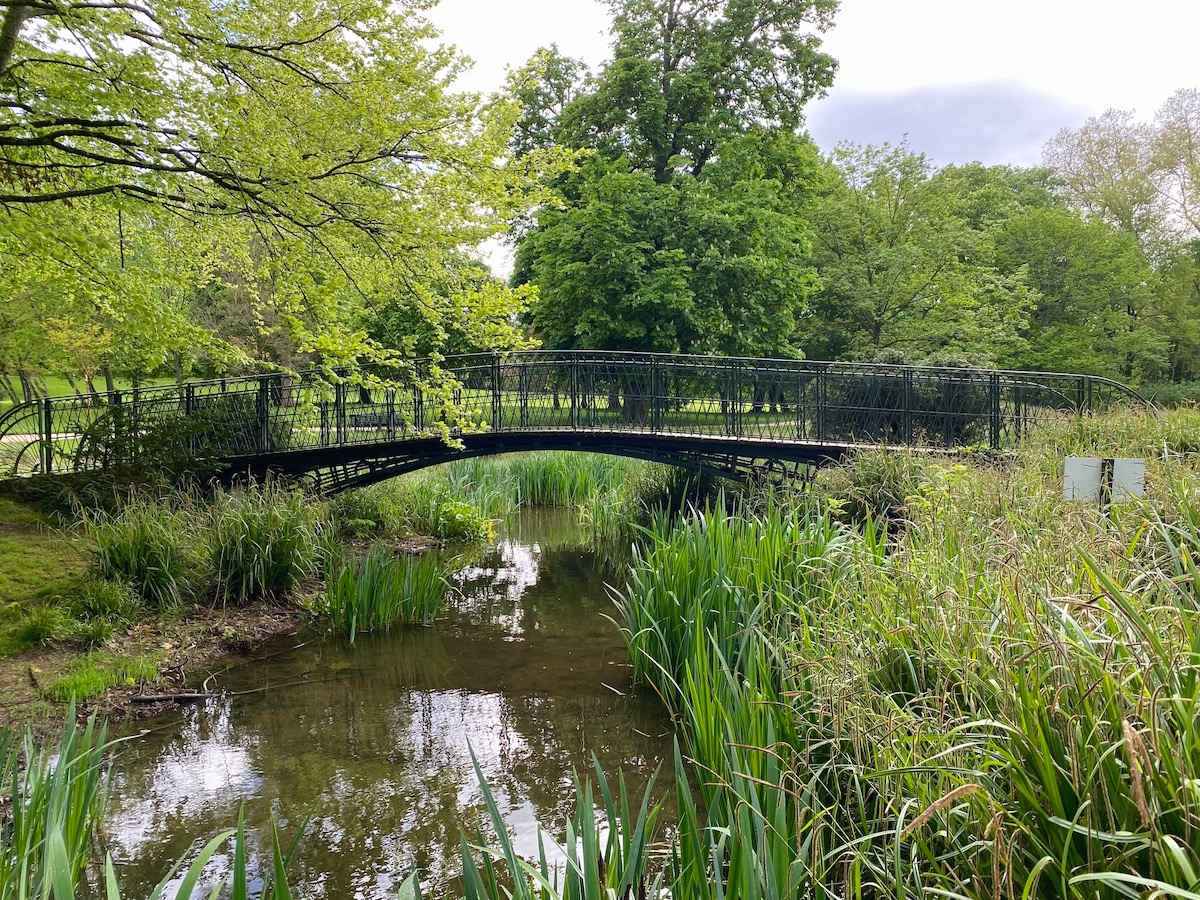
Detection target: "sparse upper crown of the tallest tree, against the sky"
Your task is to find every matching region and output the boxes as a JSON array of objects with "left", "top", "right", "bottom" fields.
[{"left": 559, "top": 0, "right": 838, "bottom": 182}]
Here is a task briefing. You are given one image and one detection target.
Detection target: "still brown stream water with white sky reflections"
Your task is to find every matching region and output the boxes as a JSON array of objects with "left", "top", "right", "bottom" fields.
[{"left": 107, "top": 512, "right": 671, "bottom": 898}]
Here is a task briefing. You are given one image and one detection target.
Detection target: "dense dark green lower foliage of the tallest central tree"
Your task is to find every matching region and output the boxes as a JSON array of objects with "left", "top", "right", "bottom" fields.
[{"left": 517, "top": 133, "right": 817, "bottom": 355}]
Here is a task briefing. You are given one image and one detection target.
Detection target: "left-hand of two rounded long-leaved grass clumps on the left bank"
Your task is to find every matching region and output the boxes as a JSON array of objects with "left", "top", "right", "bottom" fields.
[{"left": 83, "top": 499, "right": 196, "bottom": 610}]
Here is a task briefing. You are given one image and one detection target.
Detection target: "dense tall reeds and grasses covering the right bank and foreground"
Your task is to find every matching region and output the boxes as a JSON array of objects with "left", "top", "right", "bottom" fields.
[{"left": 2, "top": 410, "right": 1200, "bottom": 900}]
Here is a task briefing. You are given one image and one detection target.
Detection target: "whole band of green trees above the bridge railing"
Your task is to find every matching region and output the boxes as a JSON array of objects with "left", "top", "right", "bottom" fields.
[{"left": 0, "top": 0, "right": 1200, "bottom": 392}]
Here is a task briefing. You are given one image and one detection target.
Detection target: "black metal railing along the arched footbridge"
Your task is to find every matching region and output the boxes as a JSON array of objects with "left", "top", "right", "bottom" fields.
[{"left": 0, "top": 350, "right": 1145, "bottom": 479}]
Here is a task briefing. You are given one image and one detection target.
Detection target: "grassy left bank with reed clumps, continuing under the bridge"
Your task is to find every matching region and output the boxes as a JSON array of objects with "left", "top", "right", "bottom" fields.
[{"left": 0, "top": 454, "right": 695, "bottom": 722}]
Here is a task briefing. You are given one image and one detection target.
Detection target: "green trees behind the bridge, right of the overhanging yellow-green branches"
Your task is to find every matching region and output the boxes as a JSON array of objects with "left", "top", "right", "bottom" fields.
[{"left": 512, "top": 0, "right": 1200, "bottom": 393}]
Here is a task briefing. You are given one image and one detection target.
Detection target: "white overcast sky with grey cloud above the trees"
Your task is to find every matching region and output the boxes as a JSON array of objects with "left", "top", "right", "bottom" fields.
[{"left": 433, "top": 0, "right": 1200, "bottom": 163}]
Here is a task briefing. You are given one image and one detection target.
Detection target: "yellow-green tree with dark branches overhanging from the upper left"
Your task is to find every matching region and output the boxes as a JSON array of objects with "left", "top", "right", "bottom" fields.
[{"left": 0, "top": 0, "right": 562, "bottom": 393}]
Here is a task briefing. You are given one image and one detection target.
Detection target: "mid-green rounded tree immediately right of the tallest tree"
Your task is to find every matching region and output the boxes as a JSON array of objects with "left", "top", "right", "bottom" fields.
[{"left": 803, "top": 145, "right": 1034, "bottom": 364}]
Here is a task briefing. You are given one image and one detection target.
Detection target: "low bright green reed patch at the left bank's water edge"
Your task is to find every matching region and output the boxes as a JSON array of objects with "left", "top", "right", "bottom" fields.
[{"left": 325, "top": 547, "right": 448, "bottom": 643}]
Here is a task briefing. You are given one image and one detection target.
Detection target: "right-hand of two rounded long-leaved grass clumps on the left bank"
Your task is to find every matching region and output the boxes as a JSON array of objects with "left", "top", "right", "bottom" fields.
[{"left": 206, "top": 485, "right": 323, "bottom": 604}]
